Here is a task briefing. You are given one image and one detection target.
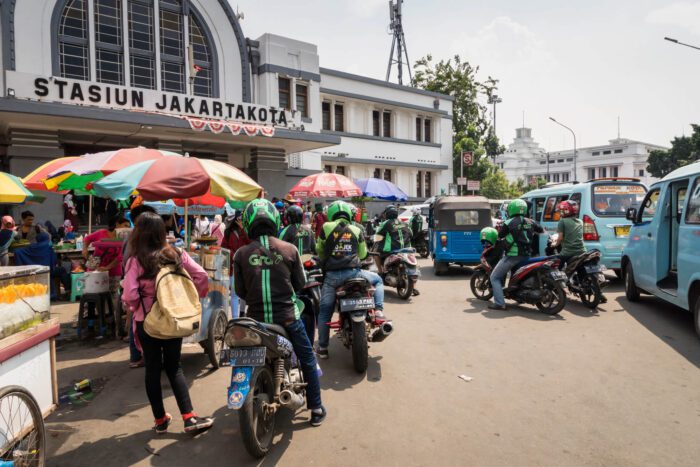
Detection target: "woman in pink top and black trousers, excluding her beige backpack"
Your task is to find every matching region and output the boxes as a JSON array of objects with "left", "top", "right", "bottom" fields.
[{"left": 122, "top": 212, "right": 214, "bottom": 434}]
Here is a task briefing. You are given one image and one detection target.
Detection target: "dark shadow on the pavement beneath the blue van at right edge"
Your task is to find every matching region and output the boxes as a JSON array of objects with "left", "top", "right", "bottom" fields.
[{"left": 617, "top": 295, "right": 700, "bottom": 368}]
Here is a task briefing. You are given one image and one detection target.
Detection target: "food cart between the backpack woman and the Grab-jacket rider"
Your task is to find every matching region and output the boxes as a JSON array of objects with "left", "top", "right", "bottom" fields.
[{"left": 183, "top": 246, "right": 231, "bottom": 368}]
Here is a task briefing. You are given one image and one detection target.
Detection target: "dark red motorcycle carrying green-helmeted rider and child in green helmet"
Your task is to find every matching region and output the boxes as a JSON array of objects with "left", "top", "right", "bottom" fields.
[{"left": 469, "top": 247, "right": 567, "bottom": 315}]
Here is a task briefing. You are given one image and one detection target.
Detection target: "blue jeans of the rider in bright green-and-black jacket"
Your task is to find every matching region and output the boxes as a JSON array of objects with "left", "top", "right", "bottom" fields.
[{"left": 318, "top": 269, "right": 384, "bottom": 349}]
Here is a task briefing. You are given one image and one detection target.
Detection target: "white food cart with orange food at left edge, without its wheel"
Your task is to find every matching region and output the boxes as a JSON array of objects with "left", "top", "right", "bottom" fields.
[{"left": 0, "top": 266, "right": 59, "bottom": 417}]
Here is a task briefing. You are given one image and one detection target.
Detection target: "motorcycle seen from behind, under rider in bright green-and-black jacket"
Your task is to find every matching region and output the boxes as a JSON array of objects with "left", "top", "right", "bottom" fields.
[{"left": 328, "top": 277, "right": 394, "bottom": 373}]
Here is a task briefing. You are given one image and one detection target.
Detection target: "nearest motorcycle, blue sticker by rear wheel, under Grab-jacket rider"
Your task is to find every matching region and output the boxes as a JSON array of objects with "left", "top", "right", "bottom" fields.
[{"left": 219, "top": 318, "right": 306, "bottom": 458}]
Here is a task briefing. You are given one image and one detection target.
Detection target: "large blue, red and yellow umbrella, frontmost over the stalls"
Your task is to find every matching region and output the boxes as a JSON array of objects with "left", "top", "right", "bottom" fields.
[{"left": 92, "top": 156, "right": 262, "bottom": 203}]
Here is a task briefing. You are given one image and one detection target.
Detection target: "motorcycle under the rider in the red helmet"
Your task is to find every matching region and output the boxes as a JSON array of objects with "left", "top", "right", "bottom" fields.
[{"left": 545, "top": 234, "right": 608, "bottom": 309}]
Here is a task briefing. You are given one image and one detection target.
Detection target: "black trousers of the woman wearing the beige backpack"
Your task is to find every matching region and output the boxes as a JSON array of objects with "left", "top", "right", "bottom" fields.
[{"left": 136, "top": 321, "right": 192, "bottom": 419}]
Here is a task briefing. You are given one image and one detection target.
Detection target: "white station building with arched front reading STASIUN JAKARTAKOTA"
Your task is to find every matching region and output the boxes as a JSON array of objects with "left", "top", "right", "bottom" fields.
[{"left": 0, "top": 0, "right": 453, "bottom": 221}]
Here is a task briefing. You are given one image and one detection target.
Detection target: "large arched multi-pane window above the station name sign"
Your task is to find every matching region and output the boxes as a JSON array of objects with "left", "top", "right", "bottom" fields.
[{"left": 57, "top": 0, "right": 216, "bottom": 97}]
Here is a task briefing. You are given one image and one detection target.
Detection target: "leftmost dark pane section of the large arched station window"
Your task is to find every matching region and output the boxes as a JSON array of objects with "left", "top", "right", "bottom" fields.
[{"left": 58, "top": 0, "right": 90, "bottom": 80}]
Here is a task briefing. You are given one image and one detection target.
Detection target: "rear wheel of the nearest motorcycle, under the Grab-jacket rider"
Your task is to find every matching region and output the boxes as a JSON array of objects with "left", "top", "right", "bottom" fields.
[{"left": 238, "top": 366, "right": 276, "bottom": 459}]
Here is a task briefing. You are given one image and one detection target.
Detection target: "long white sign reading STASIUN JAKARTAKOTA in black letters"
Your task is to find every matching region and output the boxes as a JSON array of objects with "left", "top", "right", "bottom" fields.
[{"left": 5, "top": 71, "right": 295, "bottom": 127}]
